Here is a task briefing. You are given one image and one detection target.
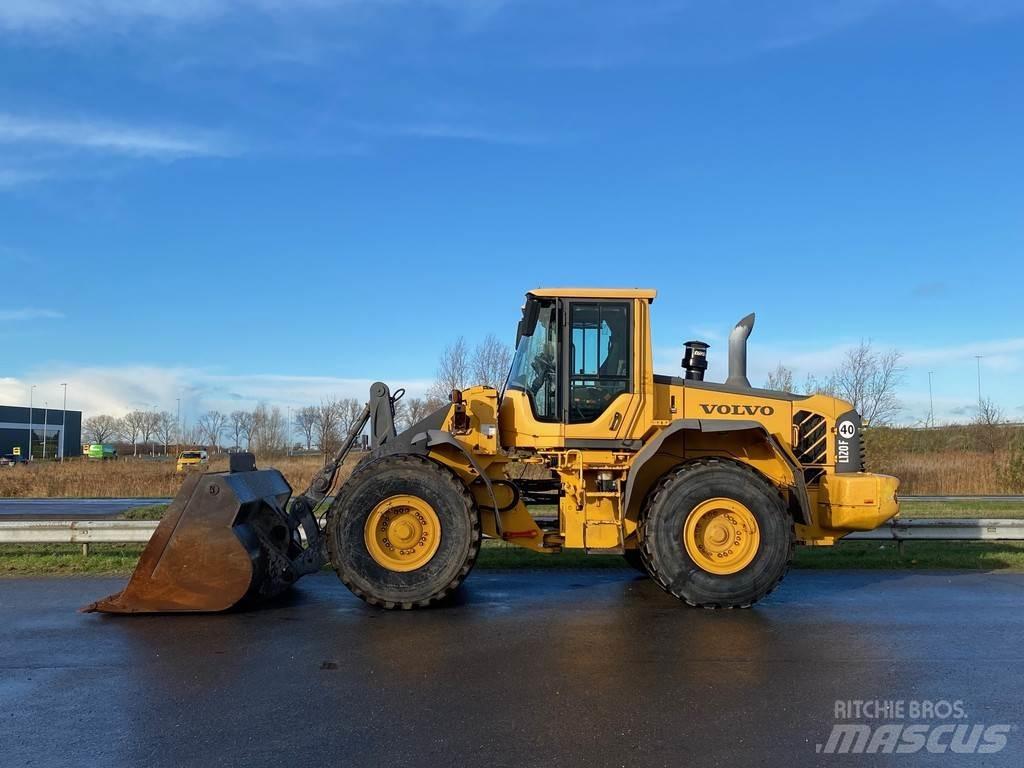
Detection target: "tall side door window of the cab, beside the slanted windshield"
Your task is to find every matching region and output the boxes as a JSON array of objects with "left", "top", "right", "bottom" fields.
[{"left": 568, "top": 301, "right": 633, "bottom": 424}]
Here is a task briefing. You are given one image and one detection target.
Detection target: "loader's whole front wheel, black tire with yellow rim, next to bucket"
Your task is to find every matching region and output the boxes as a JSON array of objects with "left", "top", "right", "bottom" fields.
[{"left": 327, "top": 455, "right": 480, "bottom": 609}]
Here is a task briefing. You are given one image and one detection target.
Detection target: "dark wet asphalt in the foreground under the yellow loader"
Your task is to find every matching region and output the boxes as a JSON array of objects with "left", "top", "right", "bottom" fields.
[{"left": 0, "top": 569, "right": 1024, "bottom": 768}]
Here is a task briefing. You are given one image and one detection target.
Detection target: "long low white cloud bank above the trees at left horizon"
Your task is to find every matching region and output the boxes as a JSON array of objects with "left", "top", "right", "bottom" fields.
[{"left": 0, "top": 365, "right": 430, "bottom": 422}]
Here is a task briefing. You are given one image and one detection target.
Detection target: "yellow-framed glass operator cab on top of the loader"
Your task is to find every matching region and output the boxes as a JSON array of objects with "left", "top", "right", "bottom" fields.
[{"left": 501, "top": 289, "right": 655, "bottom": 447}]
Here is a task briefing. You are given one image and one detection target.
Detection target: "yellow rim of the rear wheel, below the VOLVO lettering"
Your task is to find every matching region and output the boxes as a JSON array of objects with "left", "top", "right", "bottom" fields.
[{"left": 683, "top": 499, "right": 761, "bottom": 575}]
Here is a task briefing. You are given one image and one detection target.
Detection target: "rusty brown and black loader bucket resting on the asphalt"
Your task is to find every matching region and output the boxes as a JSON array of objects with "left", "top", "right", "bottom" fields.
[{"left": 82, "top": 455, "right": 324, "bottom": 613}]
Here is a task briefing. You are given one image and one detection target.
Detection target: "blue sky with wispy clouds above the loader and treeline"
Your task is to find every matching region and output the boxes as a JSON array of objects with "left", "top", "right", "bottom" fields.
[{"left": 0, "top": 0, "right": 1024, "bottom": 422}]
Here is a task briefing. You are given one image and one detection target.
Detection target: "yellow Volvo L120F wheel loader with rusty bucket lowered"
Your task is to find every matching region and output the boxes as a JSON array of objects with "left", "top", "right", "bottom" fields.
[{"left": 84, "top": 288, "right": 898, "bottom": 613}]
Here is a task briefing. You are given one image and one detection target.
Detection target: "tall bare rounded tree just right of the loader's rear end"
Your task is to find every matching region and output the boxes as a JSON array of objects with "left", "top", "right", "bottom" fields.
[{"left": 830, "top": 340, "right": 903, "bottom": 426}]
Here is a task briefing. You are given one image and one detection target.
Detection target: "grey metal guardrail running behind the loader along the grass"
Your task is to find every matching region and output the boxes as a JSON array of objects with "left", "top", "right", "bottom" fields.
[{"left": 6, "top": 518, "right": 1024, "bottom": 554}]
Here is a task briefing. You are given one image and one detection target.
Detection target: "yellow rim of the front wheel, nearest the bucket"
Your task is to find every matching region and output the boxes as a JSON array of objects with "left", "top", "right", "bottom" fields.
[{"left": 362, "top": 496, "right": 441, "bottom": 572}]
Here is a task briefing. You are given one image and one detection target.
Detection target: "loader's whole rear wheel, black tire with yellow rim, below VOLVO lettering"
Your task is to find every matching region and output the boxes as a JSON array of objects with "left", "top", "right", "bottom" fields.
[{"left": 639, "top": 458, "right": 794, "bottom": 608}]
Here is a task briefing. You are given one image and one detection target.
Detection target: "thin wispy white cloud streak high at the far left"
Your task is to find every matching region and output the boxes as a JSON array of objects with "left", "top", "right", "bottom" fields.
[{"left": 0, "top": 113, "right": 230, "bottom": 158}]
